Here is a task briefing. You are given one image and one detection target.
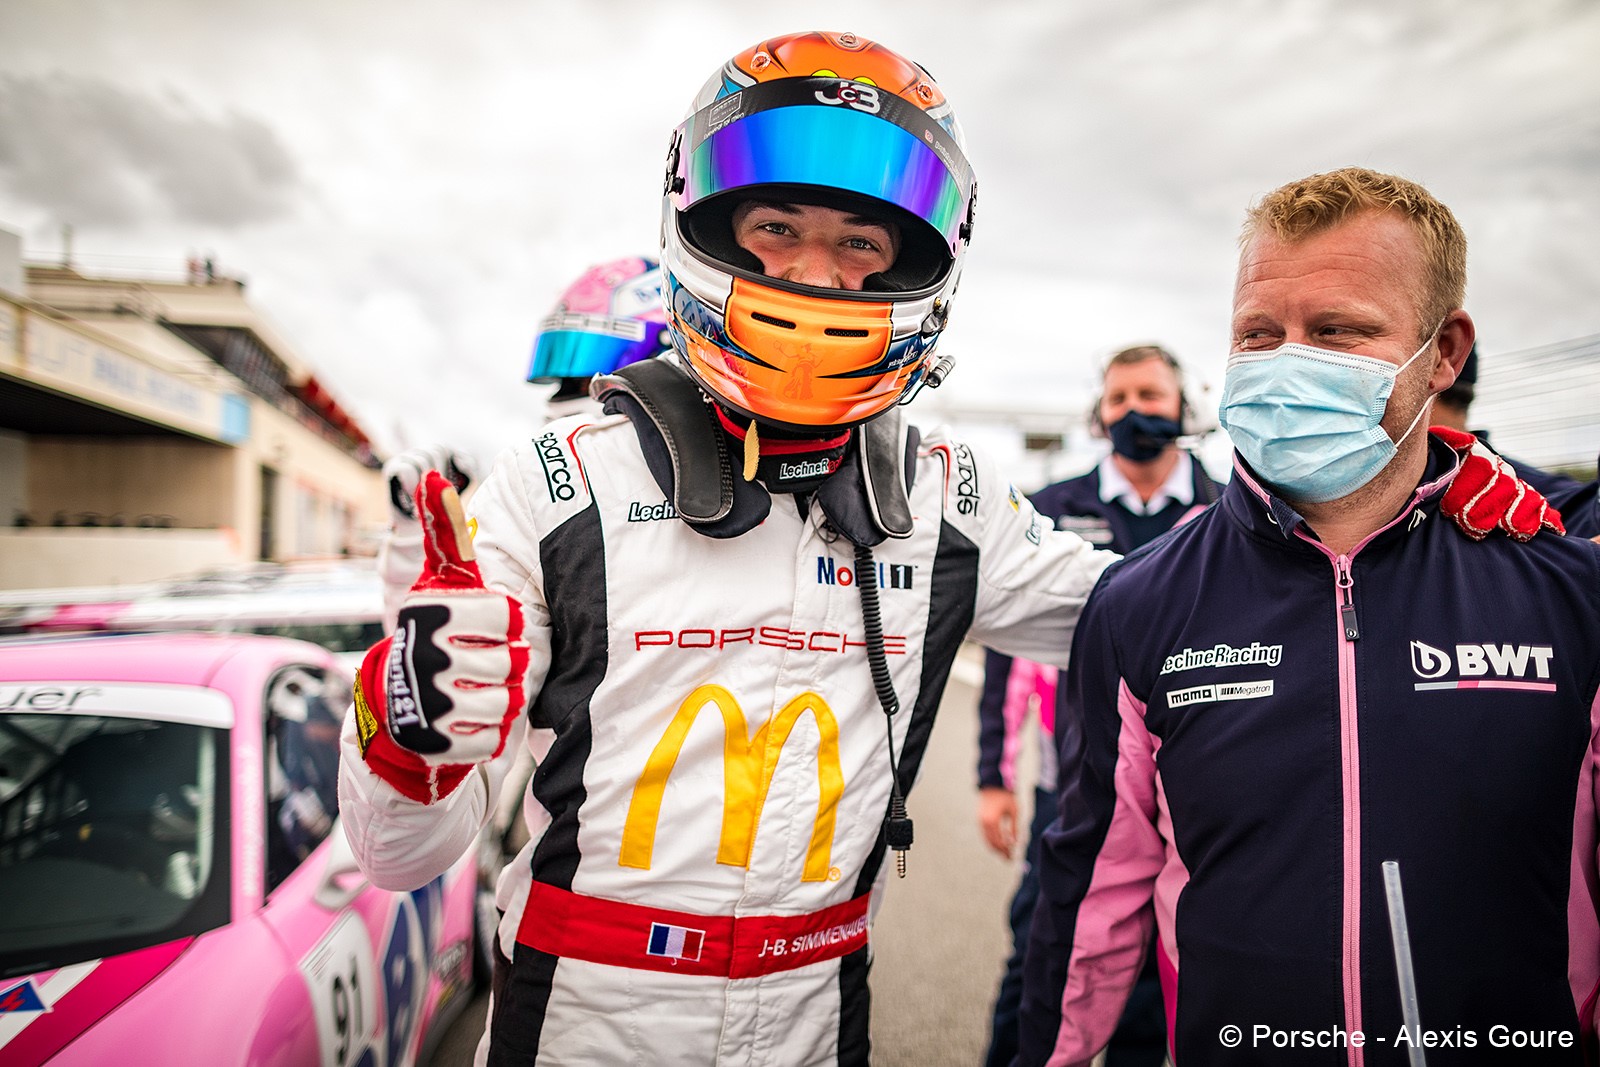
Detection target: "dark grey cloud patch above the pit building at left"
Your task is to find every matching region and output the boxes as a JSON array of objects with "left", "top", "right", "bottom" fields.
[{"left": 0, "top": 74, "right": 301, "bottom": 226}]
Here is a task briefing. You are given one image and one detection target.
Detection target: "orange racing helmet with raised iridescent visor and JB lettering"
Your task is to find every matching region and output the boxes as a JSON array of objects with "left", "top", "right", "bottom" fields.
[{"left": 661, "top": 32, "right": 976, "bottom": 432}]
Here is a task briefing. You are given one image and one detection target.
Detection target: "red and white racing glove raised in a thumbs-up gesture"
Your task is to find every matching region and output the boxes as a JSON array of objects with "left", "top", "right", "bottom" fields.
[{"left": 355, "top": 470, "right": 528, "bottom": 803}]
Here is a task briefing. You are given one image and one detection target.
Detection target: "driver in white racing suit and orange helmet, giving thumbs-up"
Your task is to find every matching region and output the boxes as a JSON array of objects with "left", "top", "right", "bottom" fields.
[{"left": 341, "top": 34, "right": 1555, "bottom": 1064}]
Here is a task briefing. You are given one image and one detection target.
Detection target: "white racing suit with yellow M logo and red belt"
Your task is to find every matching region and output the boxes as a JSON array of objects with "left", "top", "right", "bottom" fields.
[{"left": 341, "top": 403, "right": 1115, "bottom": 1067}]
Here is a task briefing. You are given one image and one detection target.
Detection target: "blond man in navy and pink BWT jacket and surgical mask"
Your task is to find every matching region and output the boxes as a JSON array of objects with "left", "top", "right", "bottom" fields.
[{"left": 1019, "top": 168, "right": 1600, "bottom": 1067}]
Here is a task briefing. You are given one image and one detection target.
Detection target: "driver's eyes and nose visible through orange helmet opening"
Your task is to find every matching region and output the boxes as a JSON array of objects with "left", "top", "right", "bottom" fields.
[{"left": 733, "top": 200, "right": 899, "bottom": 290}]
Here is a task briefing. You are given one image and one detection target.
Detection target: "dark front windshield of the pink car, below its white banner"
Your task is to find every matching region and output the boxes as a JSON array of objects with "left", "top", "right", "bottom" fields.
[{"left": 0, "top": 709, "right": 227, "bottom": 974}]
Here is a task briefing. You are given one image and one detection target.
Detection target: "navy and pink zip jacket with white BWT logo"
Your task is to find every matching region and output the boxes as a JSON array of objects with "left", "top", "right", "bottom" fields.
[{"left": 1019, "top": 442, "right": 1600, "bottom": 1067}]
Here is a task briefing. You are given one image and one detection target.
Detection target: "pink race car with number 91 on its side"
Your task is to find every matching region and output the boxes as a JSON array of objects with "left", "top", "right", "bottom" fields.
[{"left": 0, "top": 633, "right": 483, "bottom": 1067}]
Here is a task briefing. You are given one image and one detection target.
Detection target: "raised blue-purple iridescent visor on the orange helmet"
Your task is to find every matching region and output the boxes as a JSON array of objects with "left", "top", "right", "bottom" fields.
[{"left": 680, "top": 80, "right": 971, "bottom": 250}]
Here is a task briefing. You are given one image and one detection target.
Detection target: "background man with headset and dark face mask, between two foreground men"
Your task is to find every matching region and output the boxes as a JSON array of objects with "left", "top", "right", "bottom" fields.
[{"left": 978, "top": 344, "right": 1218, "bottom": 1067}]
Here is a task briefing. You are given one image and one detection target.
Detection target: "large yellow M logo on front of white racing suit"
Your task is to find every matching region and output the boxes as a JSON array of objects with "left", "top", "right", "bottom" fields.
[{"left": 618, "top": 685, "right": 845, "bottom": 881}]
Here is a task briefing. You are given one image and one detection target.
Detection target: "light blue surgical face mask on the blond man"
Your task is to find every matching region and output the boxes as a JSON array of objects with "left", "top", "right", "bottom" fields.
[{"left": 1221, "top": 323, "right": 1443, "bottom": 504}]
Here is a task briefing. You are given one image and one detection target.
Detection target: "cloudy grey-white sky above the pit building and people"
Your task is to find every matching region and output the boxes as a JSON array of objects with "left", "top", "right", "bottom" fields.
[{"left": 0, "top": 0, "right": 1600, "bottom": 476}]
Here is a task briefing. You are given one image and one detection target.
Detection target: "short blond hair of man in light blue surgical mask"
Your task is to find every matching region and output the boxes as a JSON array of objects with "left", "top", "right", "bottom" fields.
[{"left": 1238, "top": 166, "right": 1467, "bottom": 339}]
